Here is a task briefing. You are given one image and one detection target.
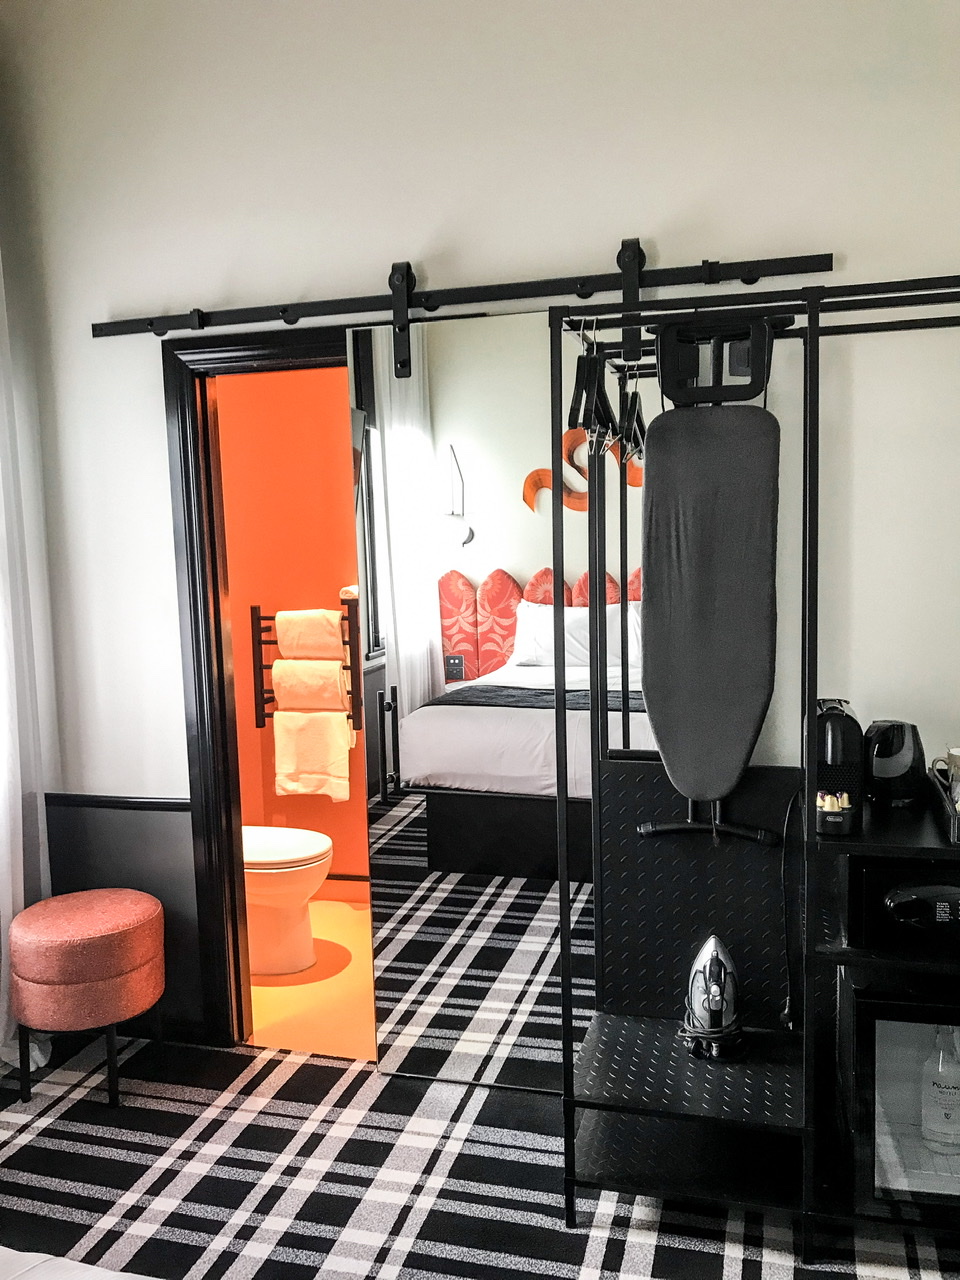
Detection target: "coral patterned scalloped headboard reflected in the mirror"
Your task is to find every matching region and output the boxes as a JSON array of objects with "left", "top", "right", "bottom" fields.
[{"left": 438, "top": 568, "right": 640, "bottom": 680}]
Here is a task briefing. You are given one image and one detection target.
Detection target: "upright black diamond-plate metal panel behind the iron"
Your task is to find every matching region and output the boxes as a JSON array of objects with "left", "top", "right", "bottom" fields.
[{"left": 596, "top": 760, "right": 800, "bottom": 1029}]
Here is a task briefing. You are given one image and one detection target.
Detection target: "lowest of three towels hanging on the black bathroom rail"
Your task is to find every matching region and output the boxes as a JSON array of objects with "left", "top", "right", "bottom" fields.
[{"left": 274, "top": 712, "right": 356, "bottom": 800}]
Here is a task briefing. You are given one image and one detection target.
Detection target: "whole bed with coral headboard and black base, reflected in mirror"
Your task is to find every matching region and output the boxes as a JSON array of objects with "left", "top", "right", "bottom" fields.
[{"left": 399, "top": 570, "right": 655, "bottom": 879}]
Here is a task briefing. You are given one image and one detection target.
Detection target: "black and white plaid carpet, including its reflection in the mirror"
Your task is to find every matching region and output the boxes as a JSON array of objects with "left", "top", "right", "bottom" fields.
[{"left": 0, "top": 803, "right": 960, "bottom": 1280}]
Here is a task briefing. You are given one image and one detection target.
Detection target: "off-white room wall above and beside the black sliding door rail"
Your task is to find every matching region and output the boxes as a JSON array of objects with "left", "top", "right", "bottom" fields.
[{"left": 0, "top": 0, "right": 960, "bottom": 795}]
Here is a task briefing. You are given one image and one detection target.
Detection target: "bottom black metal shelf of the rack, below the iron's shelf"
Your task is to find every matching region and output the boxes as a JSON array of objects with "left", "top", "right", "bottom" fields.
[{"left": 575, "top": 1111, "right": 803, "bottom": 1210}]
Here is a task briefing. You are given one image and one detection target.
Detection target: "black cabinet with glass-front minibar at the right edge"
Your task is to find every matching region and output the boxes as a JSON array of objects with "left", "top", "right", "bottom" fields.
[{"left": 814, "top": 788, "right": 960, "bottom": 1231}]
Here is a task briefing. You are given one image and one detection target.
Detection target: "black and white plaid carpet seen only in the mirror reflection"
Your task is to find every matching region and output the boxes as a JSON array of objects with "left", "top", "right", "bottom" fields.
[{"left": 370, "top": 796, "right": 593, "bottom": 1092}]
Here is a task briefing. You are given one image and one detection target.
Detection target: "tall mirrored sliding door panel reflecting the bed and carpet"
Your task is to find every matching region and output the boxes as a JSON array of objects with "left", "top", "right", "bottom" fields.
[{"left": 370, "top": 312, "right": 653, "bottom": 1091}]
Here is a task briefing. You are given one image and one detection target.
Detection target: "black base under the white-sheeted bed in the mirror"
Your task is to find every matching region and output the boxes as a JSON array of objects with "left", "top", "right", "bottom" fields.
[{"left": 425, "top": 790, "right": 593, "bottom": 881}]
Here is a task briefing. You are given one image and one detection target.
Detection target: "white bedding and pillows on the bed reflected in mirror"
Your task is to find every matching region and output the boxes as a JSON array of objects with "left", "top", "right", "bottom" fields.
[{"left": 399, "top": 663, "right": 657, "bottom": 799}]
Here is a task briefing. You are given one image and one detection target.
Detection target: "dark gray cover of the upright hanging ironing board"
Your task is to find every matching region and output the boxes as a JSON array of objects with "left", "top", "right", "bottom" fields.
[{"left": 640, "top": 404, "right": 780, "bottom": 800}]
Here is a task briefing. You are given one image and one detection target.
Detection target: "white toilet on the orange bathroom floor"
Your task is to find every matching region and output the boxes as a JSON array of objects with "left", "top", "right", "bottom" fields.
[{"left": 242, "top": 827, "right": 333, "bottom": 974}]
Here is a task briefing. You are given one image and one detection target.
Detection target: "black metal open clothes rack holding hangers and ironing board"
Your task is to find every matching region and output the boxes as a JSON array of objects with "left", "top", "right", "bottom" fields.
[{"left": 549, "top": 264, "right": 960, "bottom": 1261}]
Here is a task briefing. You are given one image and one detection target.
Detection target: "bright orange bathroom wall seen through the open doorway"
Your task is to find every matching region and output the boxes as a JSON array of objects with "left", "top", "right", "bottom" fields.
[{"left": 210, "top": 367, "right": 369, "bottom": 876}]
